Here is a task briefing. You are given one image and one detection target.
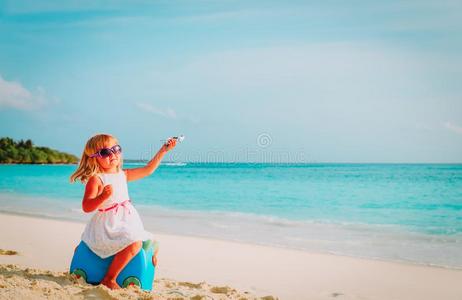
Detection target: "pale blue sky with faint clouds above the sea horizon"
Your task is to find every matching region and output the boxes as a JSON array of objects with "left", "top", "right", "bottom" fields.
[{"left": 0, "top": 0, "right": 462, "bottom": 162}]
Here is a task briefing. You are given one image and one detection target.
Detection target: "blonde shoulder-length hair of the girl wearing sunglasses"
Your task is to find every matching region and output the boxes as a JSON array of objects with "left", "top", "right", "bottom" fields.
[{"left": 70, "top": 133, "right": 123, "bottom": 183}]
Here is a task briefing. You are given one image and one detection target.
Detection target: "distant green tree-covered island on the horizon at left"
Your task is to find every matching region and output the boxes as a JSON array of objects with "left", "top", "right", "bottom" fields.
[{"left": 0, "top": 137, "right": 79, "bottom": 164}]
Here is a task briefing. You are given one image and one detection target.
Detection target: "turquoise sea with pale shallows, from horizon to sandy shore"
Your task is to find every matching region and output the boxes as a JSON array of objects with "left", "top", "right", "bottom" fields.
[{"left": 0, "top": 163, "right": 462, "bottom": 269}]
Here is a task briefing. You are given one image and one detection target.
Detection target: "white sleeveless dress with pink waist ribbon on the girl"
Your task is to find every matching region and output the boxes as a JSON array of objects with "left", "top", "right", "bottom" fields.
[{"left": 82, "top": 170, "right": 152, "bottom": 258}]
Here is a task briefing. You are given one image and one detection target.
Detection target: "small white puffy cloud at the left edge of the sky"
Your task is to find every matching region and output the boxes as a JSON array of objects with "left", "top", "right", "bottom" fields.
[{"left": 0, "top": 75, "right": 46, "bottom": 111}]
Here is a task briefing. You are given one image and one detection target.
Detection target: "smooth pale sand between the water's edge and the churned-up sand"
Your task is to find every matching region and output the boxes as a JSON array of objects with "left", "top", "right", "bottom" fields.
[{"left": 0, "top": 213, "right": 462, "bottom": 300}]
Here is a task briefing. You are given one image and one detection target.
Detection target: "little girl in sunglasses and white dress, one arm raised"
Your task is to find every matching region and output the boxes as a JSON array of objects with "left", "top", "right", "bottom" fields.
[{"left": 70, "top": 134, "right": 176, "bottom": 289}]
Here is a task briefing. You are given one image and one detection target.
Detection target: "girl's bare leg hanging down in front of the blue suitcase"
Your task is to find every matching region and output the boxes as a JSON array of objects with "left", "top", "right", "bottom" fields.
[{"left": 101, "top": 241, "right": 142, "bottom": 289}]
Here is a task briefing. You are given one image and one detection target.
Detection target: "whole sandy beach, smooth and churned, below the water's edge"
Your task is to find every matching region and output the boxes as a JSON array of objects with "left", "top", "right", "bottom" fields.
[{"left": 0, "top": 214, "right": 462, "bottom": 300}]
